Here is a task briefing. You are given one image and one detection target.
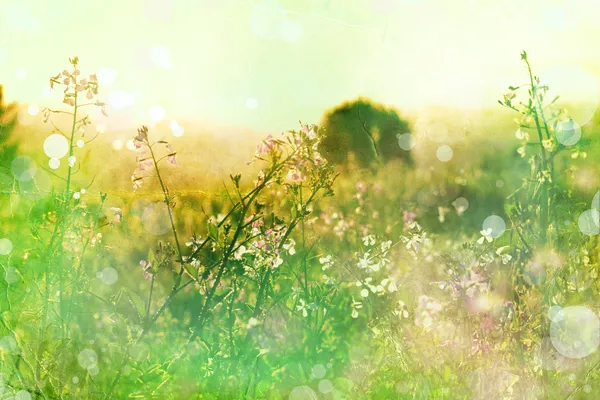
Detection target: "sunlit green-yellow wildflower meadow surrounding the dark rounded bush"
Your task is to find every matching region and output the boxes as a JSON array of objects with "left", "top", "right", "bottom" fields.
[{"left": 0, "top": 52, "right": 600, "bottom": 400}]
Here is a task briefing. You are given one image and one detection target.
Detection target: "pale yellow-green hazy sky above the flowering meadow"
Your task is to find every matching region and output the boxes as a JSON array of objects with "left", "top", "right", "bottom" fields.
[{"left": 0, "top": 0, "right": 600, "bottom": 131}]
